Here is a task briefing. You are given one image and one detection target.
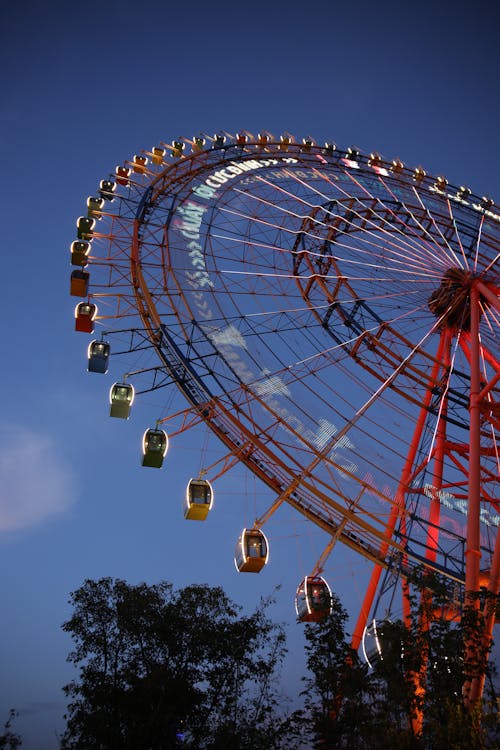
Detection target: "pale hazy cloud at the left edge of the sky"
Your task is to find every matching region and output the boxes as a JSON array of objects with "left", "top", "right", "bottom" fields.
[{"left": 0, "top": 424, "right": 76, "bottom": 532}]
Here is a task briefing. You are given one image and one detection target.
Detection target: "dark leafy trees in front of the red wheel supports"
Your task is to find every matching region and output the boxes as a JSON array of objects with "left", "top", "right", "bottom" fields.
[{"left": 298, "top": 574, "right": 500, "bottom": 750}]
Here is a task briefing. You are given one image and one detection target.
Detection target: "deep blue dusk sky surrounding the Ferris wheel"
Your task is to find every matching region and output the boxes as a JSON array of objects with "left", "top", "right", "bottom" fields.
[{"left": 0, "top": 0, "right": 500, "bottom": 750}]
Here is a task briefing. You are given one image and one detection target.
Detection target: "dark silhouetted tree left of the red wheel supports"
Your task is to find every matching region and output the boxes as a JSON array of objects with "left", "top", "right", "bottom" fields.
[{"left": 58, "top": 578, "right": 295, "bottom": 750}]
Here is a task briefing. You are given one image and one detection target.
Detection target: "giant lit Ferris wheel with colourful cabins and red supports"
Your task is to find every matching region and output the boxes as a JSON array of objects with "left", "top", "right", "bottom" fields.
[{"left": 71, "top": 132, "right": 500, "bottom": 704}]
